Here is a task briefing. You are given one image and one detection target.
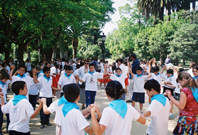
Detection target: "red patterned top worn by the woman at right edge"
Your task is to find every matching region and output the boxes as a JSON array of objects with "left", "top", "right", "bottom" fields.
[{"left": 180, "top": 88, "right": 198, "bottom": 117}]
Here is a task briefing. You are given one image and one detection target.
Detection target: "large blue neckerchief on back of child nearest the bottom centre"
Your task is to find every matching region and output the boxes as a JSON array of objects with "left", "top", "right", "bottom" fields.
[{"left": 108, "top": 99, "right": 127, "bottom": 119}]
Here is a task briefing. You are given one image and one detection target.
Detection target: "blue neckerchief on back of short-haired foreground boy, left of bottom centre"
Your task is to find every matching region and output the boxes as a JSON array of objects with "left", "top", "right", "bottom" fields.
[{"left": 62, "top": 101, "right": 79, "bottom": 117}]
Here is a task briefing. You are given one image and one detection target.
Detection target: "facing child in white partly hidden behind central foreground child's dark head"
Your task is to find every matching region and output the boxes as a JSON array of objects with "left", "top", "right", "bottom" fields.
[{"left": 110, "top": 68, "right": 127, "bottom": 100}]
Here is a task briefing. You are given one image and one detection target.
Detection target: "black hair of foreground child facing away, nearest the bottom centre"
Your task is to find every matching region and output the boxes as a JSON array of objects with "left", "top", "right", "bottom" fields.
[{"left": 105, "top": 81, "right": 126, "bottom": 99}]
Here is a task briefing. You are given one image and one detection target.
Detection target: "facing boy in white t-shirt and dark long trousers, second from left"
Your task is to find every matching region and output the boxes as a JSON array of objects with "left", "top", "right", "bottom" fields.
[{"left": 33, "top": 67, "right": 55, "bottom": 129}]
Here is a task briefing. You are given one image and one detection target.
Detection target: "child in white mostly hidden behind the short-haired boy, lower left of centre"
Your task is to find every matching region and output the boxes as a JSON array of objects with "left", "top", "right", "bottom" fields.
[{"left": 41, "top": 84, "right": 91, "bottom": 135}]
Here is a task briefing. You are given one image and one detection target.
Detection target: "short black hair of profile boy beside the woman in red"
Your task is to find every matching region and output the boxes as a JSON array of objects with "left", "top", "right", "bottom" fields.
[{"left": 144, "top": 79, "right": 160, "bottom": 93}]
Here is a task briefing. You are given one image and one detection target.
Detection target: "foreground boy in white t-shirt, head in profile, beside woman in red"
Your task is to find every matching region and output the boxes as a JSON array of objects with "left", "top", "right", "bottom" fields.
[{"left": 144, "top": 79, "right": 171, "bottom": 135}]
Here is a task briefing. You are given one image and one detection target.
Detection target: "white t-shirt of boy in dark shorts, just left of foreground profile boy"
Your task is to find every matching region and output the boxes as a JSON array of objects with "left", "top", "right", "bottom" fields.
[{"left": 133, "top": 74, "right": 147, "bottom": 93}]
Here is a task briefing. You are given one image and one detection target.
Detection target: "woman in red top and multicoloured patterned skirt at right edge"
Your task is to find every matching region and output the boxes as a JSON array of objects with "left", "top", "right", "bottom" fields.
[{"left": 166, "top": 71, "right": 198, "bottom": 135}]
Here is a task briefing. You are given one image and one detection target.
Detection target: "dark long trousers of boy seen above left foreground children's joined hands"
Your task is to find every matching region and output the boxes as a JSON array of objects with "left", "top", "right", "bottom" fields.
[{"left": 40, "top": 97, "right": 52, "bottom": 125}]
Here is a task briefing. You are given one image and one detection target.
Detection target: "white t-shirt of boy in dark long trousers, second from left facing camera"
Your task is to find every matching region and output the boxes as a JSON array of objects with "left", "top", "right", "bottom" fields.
[{"left": 38, "top": 76, "right": 52, "bottom": 98}]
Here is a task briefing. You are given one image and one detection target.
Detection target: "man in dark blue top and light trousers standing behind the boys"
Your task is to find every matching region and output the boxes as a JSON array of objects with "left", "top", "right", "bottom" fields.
[{"left": 126, "top": 53, "right": 140, "bottom": 102}]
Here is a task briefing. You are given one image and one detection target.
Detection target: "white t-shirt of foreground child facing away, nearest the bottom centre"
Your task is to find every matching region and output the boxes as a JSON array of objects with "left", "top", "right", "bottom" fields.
[{"left": 99, "top": 105, "right": 140, "bottom": 135}]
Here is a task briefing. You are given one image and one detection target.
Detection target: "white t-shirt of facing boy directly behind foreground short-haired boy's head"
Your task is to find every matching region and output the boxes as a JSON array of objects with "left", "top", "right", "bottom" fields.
[{"left": 58, "top": 74, "right": 76, "bottom": 92}]
